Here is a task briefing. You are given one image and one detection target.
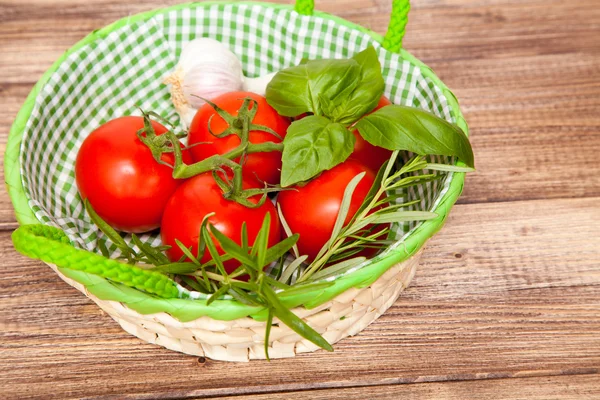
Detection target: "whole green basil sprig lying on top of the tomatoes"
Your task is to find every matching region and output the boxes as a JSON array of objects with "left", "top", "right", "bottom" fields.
[{"left": 266, "top": 47, "right": 474, "bottom": 187}]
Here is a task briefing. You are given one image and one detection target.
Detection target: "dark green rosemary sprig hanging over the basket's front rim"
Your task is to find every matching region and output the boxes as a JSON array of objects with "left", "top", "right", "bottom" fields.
[{"left": 85, "top": 201, "right": 333, "bottom": 359}]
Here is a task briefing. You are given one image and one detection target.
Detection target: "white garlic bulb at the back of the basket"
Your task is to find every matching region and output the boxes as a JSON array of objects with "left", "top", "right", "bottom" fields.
[{"left": 165, "top": 38, "right": 275, "bottom": 126}]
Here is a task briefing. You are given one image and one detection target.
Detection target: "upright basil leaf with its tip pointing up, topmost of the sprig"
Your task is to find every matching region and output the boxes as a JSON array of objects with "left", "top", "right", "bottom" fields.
[{"left": 327, "top": 46, "right": 385, "bottom": 125}]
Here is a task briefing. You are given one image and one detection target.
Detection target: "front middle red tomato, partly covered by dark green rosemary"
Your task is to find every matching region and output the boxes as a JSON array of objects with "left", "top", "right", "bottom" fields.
[{"left": 160, "top": 172, "right": 281, "bottom": 273}]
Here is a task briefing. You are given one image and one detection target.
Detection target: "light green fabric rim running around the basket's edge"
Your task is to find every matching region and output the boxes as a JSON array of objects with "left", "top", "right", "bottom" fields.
[{"left": 4, "top": 1, "right": 468, "bottom": 321}]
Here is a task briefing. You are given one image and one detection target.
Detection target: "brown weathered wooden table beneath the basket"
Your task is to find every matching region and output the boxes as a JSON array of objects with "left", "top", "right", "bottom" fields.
[{"left": 0, "top": 0, "right": 600, "bottom": 399}]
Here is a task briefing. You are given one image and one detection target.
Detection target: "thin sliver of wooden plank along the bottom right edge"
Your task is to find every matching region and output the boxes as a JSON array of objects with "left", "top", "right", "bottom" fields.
[{"left": 216, "top": 375, "right": 600, "bottom": 400}]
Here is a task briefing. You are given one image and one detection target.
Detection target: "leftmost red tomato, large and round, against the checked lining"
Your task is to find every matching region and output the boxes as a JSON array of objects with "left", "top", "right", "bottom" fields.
[{"left": 75, "top": 116, "right": 191, "bottom": 233}]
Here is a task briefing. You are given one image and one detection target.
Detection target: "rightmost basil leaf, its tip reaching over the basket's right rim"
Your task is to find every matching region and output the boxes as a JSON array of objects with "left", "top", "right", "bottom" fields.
[{"left": 356, "top": 105, "right": 475, "bottom": 167}]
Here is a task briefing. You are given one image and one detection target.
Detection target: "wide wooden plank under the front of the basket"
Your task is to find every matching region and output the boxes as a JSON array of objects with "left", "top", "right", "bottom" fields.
[{"left": 0, "top": 198, "right": 600, "bottom": 398}]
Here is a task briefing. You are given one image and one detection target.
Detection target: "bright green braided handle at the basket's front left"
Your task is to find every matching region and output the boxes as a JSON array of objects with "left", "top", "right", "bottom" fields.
[{"left": 12, "top": 225, "right": 179, "bottom": 299}]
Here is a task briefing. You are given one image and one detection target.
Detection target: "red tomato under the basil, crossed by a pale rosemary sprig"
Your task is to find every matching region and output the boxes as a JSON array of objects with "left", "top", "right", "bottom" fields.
[{"left": 277, "top": 160, "right": 375, "bottom": 261}]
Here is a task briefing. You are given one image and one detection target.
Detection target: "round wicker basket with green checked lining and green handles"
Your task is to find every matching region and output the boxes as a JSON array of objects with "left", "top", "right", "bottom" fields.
[{"left": 5, "top": 0, "right": 467, "bottom": 361}]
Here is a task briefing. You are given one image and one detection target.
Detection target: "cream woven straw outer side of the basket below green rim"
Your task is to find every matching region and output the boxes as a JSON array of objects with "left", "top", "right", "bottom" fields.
[{"left": 48, "top": 252, "right": 421, "bottom": 361}]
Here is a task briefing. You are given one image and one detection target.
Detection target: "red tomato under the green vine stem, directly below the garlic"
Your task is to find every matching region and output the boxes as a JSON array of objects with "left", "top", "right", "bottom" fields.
[{"left": 189, "top": 92, "right": 290, "bottom": 184}]
